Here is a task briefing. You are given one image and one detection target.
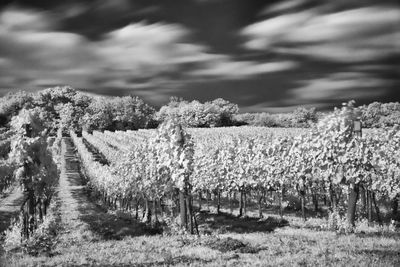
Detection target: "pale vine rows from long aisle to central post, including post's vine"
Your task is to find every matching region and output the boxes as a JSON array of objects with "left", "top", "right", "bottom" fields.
[{"left": 71, "top": 120, "right": 194, "bottom": 232}]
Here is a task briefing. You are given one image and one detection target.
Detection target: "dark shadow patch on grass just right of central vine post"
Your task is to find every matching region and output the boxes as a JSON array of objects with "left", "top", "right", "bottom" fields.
[{"left": 198, "top": 211, "right": 289, "bottom": 236}]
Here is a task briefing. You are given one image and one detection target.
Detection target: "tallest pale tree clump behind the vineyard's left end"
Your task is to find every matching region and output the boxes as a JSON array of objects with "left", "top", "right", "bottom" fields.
[{"left": 0, "top": 86, "right": 155, "bottom": 134}]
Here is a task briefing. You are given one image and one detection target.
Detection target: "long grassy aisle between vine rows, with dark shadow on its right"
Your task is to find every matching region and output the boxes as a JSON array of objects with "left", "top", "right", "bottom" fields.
[{"left": 58, "top": 138, "right": 142, "bottom": 244}]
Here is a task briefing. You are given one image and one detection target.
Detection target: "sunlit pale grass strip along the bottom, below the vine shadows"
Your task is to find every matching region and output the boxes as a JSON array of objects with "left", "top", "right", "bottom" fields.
[{"left": 3, "top": 222, "right": 400, "bottom": 266}]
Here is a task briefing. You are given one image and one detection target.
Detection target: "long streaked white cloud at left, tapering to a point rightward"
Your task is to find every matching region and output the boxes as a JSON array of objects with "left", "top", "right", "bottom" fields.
[{"left": 0, "top": 7, "right": 296, "bottom": 98}]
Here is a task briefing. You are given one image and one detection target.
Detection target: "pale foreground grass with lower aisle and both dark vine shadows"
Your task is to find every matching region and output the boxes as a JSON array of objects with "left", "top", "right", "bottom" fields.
[{"left": 3, "top": 184, "right": 400, "bottom": 266}]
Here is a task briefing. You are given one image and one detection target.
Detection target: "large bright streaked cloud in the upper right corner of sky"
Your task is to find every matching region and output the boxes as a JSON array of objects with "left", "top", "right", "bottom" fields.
[{"left": 242, "top": 7, "right": 400, "bottom": 62}]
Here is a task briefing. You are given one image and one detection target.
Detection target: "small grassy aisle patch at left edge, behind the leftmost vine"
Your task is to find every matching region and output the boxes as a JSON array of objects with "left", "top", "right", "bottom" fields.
[{"left": 0, "top": 187, "right": 23, "bottom": 233}]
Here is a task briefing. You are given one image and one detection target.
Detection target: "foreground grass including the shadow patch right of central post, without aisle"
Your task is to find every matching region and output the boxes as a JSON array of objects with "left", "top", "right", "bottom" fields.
[{"left": 3, "top": 209, "right": 400, "bottom": 266}]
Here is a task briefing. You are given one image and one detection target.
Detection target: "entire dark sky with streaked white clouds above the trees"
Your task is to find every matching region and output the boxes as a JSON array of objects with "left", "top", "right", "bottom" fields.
[{"left": 0, "top": 0, "right": 400, "bottom": 113}]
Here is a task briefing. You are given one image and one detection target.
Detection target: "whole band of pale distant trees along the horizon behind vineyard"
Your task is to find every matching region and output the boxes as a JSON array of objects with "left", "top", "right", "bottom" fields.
[{"left": 0, "top": 86, "right": 400, "bottom": 134}]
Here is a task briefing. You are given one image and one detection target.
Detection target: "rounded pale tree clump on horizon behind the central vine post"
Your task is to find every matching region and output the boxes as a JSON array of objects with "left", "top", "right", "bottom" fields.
[{"left": 155, "top": 97, "right": 239, "bottom": 127}]
